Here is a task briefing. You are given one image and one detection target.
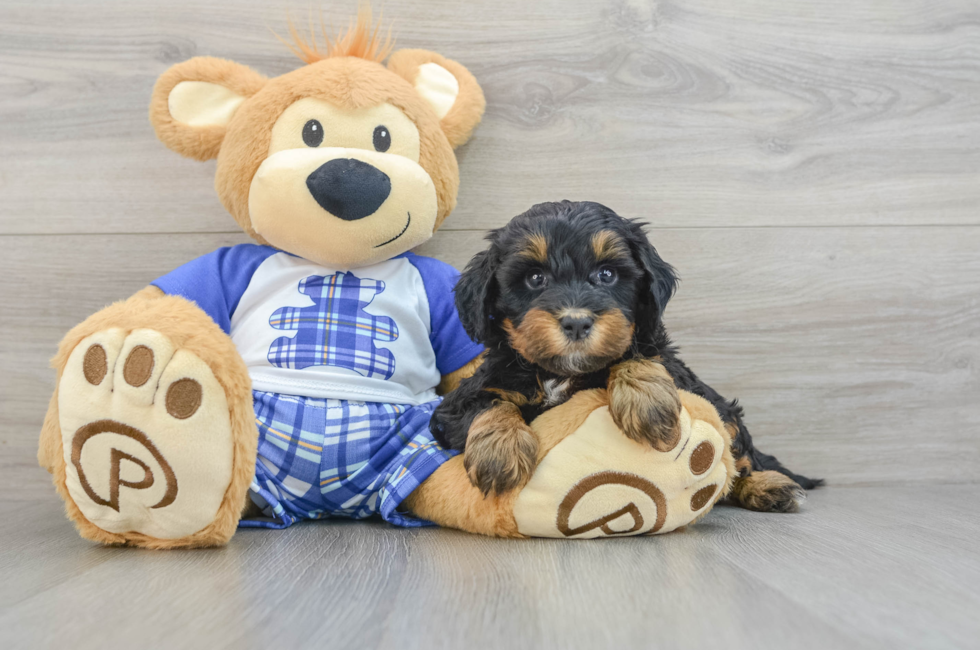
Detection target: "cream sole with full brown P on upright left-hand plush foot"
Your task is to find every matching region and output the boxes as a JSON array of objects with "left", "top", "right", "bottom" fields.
[{"left": 58, "top": 329, "right": 233, "bottom": 539}]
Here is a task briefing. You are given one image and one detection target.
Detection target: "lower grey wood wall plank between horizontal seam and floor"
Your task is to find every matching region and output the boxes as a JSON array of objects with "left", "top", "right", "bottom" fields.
[{"left": 0, "top": 227, "right": 980, "bottom": 496}]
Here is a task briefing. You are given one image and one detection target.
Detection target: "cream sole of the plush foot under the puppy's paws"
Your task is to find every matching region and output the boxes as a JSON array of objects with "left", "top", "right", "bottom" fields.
[{"left": 514, "top": 400, "right": 731, "bottom": 538}]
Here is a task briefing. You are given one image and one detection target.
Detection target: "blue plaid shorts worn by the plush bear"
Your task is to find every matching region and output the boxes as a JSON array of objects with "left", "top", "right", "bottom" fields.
[{"left": 239, "top": 391, "right": 457, "bottom": 528}]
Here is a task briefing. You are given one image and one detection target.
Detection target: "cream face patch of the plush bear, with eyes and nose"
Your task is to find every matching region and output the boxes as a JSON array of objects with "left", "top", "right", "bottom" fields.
[{"left": 248, "top": 97, "right": 436, "bottom": 261}]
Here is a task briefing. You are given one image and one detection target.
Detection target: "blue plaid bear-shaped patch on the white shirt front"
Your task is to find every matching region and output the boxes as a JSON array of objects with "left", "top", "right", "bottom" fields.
[{"left": 268, "top": 273, "right": 398, "bottom": 379}]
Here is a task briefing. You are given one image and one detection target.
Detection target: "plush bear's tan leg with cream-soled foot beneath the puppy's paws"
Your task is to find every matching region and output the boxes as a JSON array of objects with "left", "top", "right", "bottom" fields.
[{"left": 406, "top": 390, "right": 735, "bottom": 537}]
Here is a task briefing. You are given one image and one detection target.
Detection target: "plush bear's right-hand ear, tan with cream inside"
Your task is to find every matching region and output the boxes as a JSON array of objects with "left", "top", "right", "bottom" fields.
[{"left": 388, "top": 50, "right": 487, "bottom": 149}]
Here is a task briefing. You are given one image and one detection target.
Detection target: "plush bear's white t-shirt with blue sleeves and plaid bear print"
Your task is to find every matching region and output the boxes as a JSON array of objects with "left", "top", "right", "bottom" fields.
[{"left": 153, "top": 244, "right": 483, "bottom": 404}]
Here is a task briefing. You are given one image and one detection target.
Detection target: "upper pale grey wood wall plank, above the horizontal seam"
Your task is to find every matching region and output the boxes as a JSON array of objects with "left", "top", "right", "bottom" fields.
[{"left": 0, "top": 0, "right": 980, "bottom": 234}]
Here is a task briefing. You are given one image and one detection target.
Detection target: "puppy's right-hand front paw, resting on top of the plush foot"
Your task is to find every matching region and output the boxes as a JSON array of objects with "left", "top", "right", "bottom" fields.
[{"left": 609, "top": 360, "right": 681, "bottom": 451}]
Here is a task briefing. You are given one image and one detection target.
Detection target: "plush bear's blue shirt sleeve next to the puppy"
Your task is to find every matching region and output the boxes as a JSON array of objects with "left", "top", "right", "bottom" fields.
[{"left": 406, "top": 253, "right": 483, "bottom": 375}]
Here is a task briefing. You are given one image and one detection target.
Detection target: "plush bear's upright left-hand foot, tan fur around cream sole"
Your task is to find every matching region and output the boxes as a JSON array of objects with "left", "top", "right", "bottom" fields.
[{"left": 38, "top": 287, "right": 258, "bottom": 548}]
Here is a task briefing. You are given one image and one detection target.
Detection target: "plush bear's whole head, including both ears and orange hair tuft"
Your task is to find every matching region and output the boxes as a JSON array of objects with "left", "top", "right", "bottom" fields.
[{"left": 150, "top": 8, "right": 485, "bottom": 268}]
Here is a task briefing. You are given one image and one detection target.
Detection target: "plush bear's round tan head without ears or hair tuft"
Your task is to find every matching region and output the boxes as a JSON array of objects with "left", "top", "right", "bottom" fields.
[{"left": 216, "top": 57, "right": 459, "bottom": 267}]
